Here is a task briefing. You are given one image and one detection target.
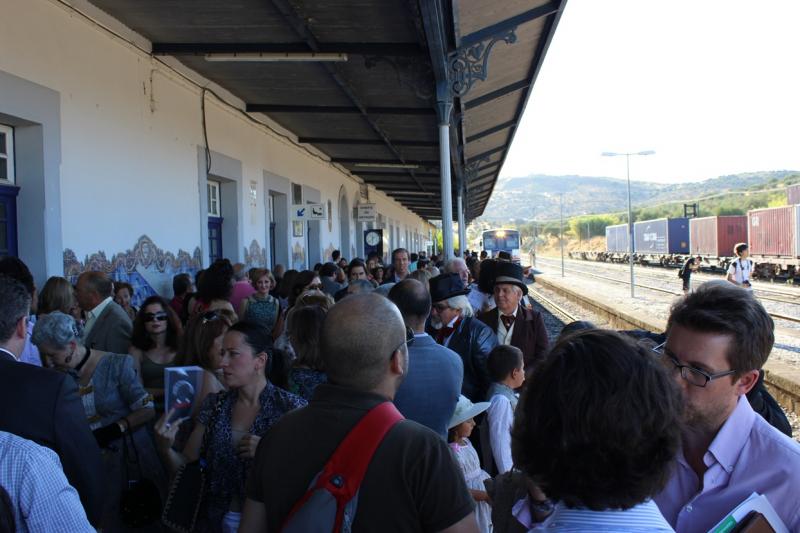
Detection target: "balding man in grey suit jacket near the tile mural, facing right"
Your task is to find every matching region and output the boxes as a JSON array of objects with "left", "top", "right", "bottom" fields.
[{"left": 75, "top": 272, "right": 133, "bottom": 353}]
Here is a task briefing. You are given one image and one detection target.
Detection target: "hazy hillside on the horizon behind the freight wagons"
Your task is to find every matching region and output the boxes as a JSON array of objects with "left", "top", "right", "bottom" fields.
[{"left": 479, "top": 170, "right": 800, "bottom": 224}]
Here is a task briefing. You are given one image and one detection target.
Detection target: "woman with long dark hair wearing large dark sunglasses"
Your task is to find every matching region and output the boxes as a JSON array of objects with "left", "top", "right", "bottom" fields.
[{"left": 130, "top": 296, "right": 183, "bottom": 412}]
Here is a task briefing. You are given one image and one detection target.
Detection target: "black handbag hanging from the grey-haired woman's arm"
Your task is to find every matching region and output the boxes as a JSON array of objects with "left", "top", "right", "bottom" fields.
[{"left": 119, "top": 432, "right": 161, "bottom": 527}]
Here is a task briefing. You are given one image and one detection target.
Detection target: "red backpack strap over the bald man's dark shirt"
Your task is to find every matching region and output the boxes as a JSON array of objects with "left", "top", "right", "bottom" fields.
[{"left": 287, "top": 401, "right": 404, "bottom": 532}]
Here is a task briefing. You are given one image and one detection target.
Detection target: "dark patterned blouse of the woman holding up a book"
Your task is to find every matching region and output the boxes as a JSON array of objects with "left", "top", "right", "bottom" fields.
[{"left": 197, "top": 382, "right": 307, "bottom": 527}]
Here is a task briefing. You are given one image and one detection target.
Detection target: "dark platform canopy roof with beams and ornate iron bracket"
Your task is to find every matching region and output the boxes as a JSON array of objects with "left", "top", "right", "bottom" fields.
[{"left": 90, "top": 0, "right": 566, "bottom": 220}]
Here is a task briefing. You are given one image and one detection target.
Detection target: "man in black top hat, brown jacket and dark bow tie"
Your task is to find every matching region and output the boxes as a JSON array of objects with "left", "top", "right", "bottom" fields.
[{"left": 478, "top": 261, "right": 548, "bottom": 371}]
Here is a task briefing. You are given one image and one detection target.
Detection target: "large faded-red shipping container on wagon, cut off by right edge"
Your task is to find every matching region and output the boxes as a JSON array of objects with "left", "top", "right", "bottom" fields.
[{"left": 747, "top": 205, "right": 800, "bottom": 258}]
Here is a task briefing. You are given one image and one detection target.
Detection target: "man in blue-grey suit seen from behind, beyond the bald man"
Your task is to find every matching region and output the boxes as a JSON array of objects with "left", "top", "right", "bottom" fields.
[{"left": 389, "top": 278, "right": 464, "bottom": 439}]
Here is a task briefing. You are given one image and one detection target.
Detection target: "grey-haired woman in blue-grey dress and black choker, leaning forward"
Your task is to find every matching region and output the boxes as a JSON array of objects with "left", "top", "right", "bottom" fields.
[{"left": 31, "top": 311, "right": 166, "bottom": 531}]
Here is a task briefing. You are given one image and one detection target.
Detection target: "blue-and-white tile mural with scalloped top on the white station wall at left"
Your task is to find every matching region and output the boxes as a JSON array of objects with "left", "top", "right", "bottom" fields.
[{"left": 64, "top": 235, "right": 203, "bottom": 307}]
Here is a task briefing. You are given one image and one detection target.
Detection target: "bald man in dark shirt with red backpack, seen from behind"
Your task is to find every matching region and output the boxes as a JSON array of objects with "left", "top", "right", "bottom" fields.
[{"left": 239, "top": 294, "right": 478, "bottom": 533}]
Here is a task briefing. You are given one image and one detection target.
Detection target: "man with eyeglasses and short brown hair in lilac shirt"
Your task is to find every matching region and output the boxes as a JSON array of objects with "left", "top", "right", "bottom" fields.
[{"left": 655, "top": 282, "right": 800, "bottom": 533}]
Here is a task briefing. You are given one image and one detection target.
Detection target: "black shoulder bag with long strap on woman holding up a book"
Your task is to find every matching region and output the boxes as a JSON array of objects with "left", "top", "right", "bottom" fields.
[{"left": 161, "top": 394, "right": 224, "bottom": 533}]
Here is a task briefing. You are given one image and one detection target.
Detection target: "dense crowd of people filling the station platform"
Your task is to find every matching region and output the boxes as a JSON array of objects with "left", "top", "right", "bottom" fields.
[{"left": 0, "top": 249, "right": 800, "bottom": 533}]
